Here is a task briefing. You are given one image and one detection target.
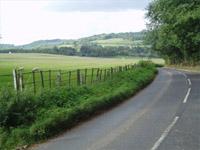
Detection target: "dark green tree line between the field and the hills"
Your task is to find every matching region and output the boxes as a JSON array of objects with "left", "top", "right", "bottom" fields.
[{"left": 0, "top": 44, "right": 158, "bottom": 57}]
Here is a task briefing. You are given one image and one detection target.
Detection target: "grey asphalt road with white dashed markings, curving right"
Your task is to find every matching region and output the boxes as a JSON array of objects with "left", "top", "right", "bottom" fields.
[{"left": 33, "top": 69, "right": 200, "bottom": 150}]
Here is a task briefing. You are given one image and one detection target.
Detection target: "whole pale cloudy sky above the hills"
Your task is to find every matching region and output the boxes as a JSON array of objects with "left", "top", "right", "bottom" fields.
[{"left": 0, "top": 0, "right": 150, "bottom": 45}]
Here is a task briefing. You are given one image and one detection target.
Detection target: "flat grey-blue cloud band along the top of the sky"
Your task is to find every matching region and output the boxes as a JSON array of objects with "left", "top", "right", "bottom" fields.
[{"left": 47, "top": 0, "right": 151, "bottom": 12}]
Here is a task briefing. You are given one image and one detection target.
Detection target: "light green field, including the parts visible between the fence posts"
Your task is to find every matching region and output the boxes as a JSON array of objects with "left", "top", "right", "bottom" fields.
[{"left": 0, "top": 53, "right": 163, "bottom": 87}]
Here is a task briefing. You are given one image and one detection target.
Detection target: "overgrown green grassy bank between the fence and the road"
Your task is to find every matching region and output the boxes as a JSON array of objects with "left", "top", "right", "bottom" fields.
[{"left": 0, "top": 63, "right": 157, "bottom": 150}]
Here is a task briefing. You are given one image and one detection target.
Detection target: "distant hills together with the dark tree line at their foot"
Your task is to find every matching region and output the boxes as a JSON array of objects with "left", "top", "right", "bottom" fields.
[{"left": 0, "top": 32, "right": 158, "bottom": 57}]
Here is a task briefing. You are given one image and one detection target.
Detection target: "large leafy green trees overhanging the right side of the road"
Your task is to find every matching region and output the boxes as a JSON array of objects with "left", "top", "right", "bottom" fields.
[{"left": 147, "top": 0, "right": 200, "bottom": 64}]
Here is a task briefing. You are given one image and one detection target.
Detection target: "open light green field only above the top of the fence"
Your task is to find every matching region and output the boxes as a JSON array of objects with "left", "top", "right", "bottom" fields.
[{"left": 0, "top": 53, "right": 164, "bottom": 75}]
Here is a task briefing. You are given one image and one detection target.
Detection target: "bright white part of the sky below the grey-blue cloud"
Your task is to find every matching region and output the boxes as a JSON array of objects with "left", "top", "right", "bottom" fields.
[{"left": 0, "top": 0, "right": 145, "bottom": 44}]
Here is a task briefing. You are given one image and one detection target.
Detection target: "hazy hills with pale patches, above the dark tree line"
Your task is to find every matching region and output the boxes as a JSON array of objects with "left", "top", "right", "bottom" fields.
[{"left": 0, "top": 32, "right": 144, "bottom": 50}]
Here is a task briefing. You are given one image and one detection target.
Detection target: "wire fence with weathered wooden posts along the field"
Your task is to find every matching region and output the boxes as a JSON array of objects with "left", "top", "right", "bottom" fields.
[{"left": 0, "top": 64, "right": 137, "bottom": 93}]
